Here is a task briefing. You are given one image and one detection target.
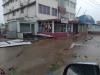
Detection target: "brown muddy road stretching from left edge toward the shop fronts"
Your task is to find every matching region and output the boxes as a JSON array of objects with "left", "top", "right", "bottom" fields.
[{"left": 0, "top": 39, "right": 72, "bottom": 75}]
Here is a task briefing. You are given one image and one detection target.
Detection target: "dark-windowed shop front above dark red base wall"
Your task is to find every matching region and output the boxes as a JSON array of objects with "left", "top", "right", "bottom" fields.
[{"left": 38, "top": 19, "right": 67, "bottom": 37}]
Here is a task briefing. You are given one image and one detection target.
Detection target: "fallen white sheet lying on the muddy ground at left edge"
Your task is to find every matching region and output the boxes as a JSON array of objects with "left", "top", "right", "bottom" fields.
[{"left": 0, "top": 39, "right": 31, "bottom": 48}]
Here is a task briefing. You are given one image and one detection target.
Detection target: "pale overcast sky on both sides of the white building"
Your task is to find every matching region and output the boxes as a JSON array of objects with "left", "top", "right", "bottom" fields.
[{"left": 0, "top": 0, "right": 100, "bottom": 23}]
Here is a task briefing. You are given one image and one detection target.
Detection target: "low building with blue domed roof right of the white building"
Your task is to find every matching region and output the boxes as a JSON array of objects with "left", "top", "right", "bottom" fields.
[{"left": 69, "top": 15, "right": 95, "bottom": 39}]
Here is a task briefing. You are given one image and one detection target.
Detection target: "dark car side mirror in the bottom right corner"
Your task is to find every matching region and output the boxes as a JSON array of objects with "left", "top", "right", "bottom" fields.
[{"left": 63, "top": 62, "right": 100, "bottom": 75}]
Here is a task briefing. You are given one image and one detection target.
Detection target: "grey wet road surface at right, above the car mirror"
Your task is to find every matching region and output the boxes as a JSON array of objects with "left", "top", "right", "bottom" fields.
[{"left": 72, "top": 36, "right": 100, "bottom": 63}]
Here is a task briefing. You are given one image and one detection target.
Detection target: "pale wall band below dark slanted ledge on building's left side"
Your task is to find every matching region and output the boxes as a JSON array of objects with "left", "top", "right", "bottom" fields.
[{"left": 4, "top": 5, "right": 36, "bottom": 22}]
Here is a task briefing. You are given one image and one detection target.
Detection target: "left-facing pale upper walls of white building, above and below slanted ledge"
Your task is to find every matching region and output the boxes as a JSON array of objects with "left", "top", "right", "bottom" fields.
[{"left": 4, "top": 0, "right": 36, "bottom": 23}]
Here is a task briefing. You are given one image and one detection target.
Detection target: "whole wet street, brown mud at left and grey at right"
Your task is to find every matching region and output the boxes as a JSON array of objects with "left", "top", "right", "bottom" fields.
[{"left": 0, "top": 36, "right": 100, "bottom": 75}]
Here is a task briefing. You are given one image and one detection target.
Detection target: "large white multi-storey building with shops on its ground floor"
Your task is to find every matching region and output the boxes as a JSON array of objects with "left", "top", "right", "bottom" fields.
[{"left": 3, "top": 0, "right": 76, "bottom": 38}]
